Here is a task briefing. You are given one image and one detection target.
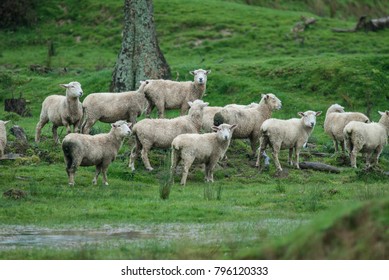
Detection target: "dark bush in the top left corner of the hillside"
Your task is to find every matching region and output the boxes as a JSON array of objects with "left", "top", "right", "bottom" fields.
[{"left": 0, "top": 0, "right": 37, "bottom": 28}]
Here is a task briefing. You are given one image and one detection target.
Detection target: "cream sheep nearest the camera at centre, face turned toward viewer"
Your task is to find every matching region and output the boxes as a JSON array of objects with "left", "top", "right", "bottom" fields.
[{"left": 171, "top": 124, "right": 236, "bottom": 186}]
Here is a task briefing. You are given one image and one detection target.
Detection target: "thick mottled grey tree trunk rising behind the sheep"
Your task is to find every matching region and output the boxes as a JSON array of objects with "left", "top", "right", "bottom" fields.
[{"left": 111, "top": 0, "right": 170, "bottom": 92}]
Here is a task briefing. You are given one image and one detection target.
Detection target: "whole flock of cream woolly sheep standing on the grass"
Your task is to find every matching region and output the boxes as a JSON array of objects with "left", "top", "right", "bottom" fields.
[{"left": 0, "top": 69, "right": 389, "bottom": 186}]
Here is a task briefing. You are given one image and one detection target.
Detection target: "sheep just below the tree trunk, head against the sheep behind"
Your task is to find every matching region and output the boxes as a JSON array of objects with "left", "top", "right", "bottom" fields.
[{"left": 81, "top": 81, "right": 148, "bottom": 134}]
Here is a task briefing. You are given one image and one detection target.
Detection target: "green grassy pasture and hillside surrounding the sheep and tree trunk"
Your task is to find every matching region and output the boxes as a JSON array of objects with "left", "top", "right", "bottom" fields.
[{"left": 0, "top": 0, "right": 389, "bottom": 259}]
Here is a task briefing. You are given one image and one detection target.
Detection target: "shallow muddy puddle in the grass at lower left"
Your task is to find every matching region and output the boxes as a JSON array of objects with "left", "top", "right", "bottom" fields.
[{"left": 0, "top": 229, "right": 156, "bottom": 249}]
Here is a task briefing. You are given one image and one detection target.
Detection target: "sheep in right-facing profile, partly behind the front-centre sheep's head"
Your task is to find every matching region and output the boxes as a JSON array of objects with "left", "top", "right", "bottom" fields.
[{"left": 214, "top": 93, "right": 282, "bottom": 154}]
